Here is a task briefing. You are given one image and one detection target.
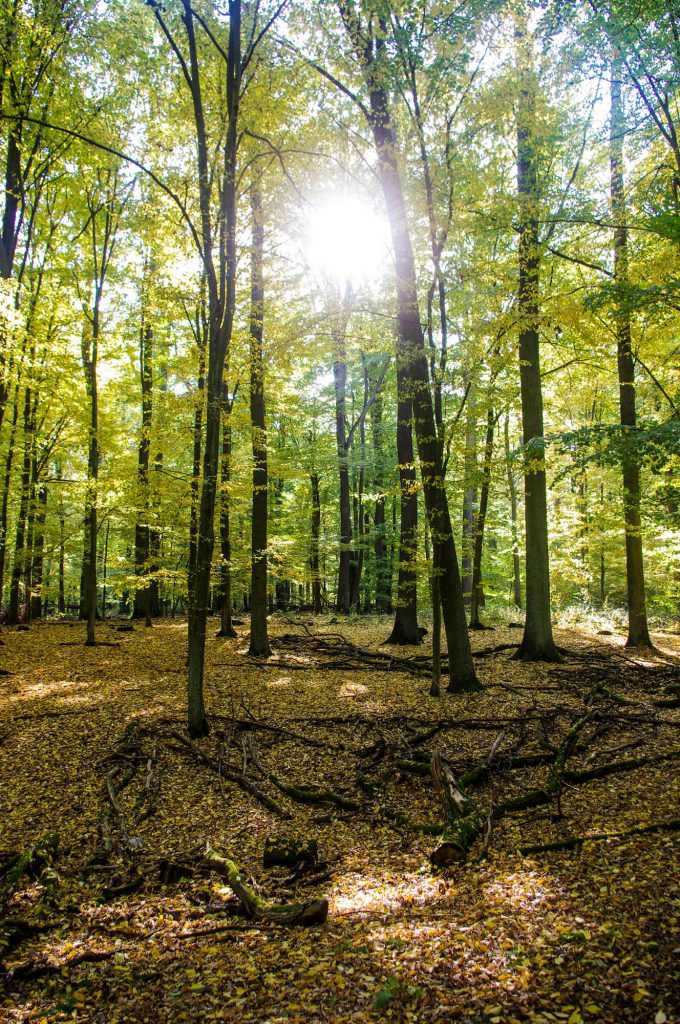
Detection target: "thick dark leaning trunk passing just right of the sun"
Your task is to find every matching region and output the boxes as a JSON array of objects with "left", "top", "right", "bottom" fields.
[{"left": 339, "top": 9, "right": 479, "bottom": 691}]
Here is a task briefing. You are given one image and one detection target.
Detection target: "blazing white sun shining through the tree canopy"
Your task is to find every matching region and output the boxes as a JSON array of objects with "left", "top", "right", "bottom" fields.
[{"left": 305, "top": 194, "right": 390, "bottom": 289}]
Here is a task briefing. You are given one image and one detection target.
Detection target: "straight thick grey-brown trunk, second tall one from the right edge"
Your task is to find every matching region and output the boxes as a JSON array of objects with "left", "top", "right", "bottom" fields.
[{"left": 516, "top": 30, "right": 559, "bottom": 662}]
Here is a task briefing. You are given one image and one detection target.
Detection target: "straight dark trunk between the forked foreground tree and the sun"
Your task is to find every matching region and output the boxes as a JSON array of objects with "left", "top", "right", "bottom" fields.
[{"left": 249, "top": 177, "right": 271, "bottom": 657}]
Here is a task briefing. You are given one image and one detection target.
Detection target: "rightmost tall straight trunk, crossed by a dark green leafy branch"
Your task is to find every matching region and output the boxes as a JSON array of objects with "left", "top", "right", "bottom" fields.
[{"left": 609, "top": 56, "right": 651, "bottom": 647}]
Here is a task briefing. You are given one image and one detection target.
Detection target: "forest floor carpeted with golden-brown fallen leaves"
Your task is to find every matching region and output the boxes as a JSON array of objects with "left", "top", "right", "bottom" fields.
[{"left": 0, "top": 615, "right": 680, "bottom": 1024}]
